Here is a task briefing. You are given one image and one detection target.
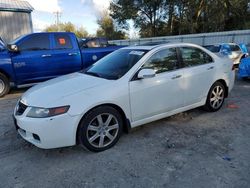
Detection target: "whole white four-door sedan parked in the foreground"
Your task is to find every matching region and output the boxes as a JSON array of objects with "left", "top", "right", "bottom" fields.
[{"left": 14, "top": 43, "right": 234, "bottom": 151}]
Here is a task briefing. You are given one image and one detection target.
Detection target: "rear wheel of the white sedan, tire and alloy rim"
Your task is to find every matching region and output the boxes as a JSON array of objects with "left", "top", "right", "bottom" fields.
[{"left": 204, "top": 82, "right": 225, "bottom": 112}]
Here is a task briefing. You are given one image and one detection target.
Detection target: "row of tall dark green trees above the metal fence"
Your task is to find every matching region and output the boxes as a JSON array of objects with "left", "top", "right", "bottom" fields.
[{"left": 110, "top": 0, "right": 250, "bottom": 37}]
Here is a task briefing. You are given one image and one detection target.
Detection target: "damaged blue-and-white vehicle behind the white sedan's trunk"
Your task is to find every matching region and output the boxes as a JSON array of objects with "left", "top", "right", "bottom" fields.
[{"left": 204, "top": 43, "right": 249, "bottom": 66}]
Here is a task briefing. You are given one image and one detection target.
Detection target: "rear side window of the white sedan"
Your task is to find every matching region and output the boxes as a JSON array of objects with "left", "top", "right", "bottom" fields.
[{"left": 180, "top": 47, "right": 213, "bottom": 67}]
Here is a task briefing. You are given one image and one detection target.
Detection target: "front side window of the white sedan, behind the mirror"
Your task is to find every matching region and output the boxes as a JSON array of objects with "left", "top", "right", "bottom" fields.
[{"left": 142, "top": 48, "right": 177, "bottom": 74}]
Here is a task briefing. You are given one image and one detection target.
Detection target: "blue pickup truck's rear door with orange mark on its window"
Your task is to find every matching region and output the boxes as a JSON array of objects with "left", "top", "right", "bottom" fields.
[{"left": 51, "top": 33, "right": 82, "bottom": 76}]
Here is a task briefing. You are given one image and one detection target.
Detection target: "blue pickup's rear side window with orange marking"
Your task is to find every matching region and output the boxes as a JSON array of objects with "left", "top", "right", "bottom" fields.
[{"left": 55, "top": 34, "right": 73, "bottom": 49}]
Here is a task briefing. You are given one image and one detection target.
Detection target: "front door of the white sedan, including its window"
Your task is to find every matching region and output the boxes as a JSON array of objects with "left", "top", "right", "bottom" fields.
[{"left": 129, "top": 48, "right": 184, "bottom": 121}]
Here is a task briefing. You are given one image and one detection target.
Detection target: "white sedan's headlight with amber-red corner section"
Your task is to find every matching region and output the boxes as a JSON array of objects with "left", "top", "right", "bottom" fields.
[{"left": 27, "top": 106, "right": 69, "bottom": 118}]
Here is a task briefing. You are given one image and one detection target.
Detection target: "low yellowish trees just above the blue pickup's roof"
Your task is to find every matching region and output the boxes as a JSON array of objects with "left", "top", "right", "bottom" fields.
[{"left": 44, "top": 22, "right": 89, "bottom": 38}]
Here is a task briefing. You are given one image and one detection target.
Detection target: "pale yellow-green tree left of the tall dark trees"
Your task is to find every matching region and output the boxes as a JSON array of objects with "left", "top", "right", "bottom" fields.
[{"left": 96, "top": 11, "right": 127, "bottom": 40}]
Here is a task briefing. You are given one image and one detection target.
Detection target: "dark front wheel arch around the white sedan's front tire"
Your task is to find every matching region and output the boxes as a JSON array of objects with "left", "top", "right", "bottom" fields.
[{"left": 75, "top": 103, "right": 131, "bottom": 144}]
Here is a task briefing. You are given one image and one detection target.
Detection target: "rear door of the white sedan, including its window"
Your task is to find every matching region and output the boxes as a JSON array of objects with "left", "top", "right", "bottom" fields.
[{"left": 179, "top": 47, "right": 216, "bottom": 106}]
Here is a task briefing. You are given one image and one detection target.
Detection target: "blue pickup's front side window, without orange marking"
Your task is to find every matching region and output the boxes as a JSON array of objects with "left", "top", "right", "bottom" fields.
[{"left": 19, "top": 34, "right": 50, "bottom": 51}]
